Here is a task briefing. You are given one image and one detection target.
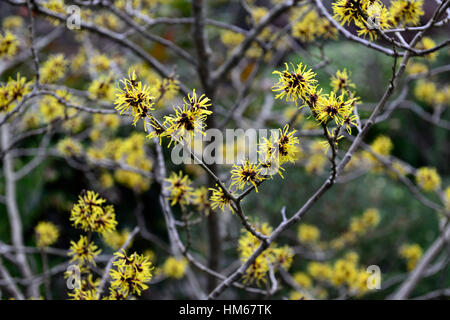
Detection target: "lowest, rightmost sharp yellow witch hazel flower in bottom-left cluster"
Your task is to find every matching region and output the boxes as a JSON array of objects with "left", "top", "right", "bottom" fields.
[{"left": 110, "top": 250, "right": 154, "bottom": 297}]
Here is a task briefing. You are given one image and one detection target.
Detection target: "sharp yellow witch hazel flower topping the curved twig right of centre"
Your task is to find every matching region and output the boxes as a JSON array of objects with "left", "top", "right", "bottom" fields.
[{"left": 272, "top": 62, "right": 317, "bottom": 104}]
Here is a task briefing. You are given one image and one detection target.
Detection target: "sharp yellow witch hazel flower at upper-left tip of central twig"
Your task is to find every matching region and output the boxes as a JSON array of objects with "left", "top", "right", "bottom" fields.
[{"left": 114, "top": 70, "right": 154, "bottom": 131}]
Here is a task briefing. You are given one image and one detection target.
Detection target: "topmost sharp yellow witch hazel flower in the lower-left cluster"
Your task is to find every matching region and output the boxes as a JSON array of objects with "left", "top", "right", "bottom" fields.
[{"left": 70, "top": 191, "right": 117, "bottom": 234}]
